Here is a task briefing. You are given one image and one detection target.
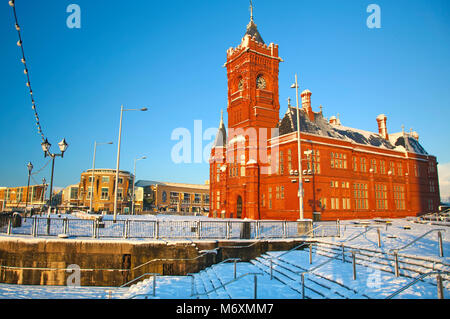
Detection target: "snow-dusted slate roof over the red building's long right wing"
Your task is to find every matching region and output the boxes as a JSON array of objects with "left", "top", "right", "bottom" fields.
[{"left": 279, "top": 107, "right": 428, "bottom": 155}]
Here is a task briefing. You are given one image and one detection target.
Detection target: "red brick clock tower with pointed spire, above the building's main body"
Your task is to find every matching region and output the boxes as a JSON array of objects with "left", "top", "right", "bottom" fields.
[{"left": 224, "top": 7, "right": 282, "bottom": 138}]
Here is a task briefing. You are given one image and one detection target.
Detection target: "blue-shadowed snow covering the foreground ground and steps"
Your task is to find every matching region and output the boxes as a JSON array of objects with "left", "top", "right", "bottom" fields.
[{"left": 0, "top": 215, "right": 450, "bottom": 299}]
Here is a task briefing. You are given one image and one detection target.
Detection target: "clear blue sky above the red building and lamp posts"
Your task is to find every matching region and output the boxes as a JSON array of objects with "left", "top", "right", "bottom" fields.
[{"left": 0, "top": 0, "right": 450, "bottom": 198}]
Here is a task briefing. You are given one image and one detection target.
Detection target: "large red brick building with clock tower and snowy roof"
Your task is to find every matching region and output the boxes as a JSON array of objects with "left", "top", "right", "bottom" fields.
[{"left": 210, "top": 13, "right": 440, "bottom": 220}]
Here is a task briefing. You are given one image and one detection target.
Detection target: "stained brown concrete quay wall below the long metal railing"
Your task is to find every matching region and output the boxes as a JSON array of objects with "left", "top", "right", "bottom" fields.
[{"left": 0, "top": 236, "right": 306, "bottom": 286}]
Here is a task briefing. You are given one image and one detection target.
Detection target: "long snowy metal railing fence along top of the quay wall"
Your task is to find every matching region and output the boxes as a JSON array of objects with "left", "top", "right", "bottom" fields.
[{"left": 0, "top": 216, "right": 339, "bottom": 239}]
